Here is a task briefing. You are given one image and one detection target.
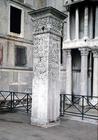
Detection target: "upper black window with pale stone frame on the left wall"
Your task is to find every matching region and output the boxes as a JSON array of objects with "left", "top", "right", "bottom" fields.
[{"left": 8, "top": 4, "right": 24, "bottom": 37}]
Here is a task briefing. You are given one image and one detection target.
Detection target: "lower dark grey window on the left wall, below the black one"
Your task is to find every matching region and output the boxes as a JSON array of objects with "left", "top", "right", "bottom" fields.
[{"left": 15, "top": 46, "right": 27, "bottom": 66}]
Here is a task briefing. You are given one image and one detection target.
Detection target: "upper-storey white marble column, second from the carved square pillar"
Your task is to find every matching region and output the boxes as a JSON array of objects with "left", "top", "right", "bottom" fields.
[{"left": 75, "top": 8, "right": 79, "bottom": 40}]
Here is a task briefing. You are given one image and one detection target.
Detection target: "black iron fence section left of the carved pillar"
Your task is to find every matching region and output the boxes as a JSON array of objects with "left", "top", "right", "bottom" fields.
[{"left": 0, "top": 91, "right": 32, "bottom": 112}]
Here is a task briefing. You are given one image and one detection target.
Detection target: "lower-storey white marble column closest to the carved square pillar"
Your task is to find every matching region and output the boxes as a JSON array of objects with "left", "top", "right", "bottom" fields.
[{"left": 66, "top": 50, "right": 72, "bottom": 102}]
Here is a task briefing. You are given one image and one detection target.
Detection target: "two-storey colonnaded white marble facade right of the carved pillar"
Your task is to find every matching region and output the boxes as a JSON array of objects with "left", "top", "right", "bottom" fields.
[{"left": 63, "top": 0, "right": 98, "bottom": 105}]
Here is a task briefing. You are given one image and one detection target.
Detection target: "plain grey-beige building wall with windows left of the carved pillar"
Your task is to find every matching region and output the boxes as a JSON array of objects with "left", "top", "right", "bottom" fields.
[{"left": 0, "top": 0, "right": 33, "bottom": 91}]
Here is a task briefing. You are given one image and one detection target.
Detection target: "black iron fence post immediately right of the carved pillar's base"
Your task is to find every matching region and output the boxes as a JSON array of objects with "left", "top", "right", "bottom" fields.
[{"left": 60, "top": 94, "right": 65, "bottom": 116}]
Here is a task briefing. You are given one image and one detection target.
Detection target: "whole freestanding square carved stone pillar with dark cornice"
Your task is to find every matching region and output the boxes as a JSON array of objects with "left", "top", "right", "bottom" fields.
[{"left": 30, "top": 7, "right": 66, "bottom": 126}]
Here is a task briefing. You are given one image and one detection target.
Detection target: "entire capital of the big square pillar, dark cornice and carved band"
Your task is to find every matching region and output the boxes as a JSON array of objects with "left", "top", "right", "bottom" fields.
[{"left": 29, "top": 7, "right": 67, "bottom": 36}]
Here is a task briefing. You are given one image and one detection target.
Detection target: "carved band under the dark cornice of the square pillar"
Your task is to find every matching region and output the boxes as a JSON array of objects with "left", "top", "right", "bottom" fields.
[{"left": 32, "top": 16, "right": 62, "bottom": 35}]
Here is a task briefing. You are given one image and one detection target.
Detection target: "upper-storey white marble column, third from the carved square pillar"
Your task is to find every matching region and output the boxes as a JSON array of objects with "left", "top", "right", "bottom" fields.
[{"left": 84, "top": 7, "right": 88, "bottom": 38}]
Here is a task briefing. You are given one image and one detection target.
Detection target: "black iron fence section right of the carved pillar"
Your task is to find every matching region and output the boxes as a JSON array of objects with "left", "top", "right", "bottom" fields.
[{"left": 60, "top": 94, "right": 98, "bottom": 120}]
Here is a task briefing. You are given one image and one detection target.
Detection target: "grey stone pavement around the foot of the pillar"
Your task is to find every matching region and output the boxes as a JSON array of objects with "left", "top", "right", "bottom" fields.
[{"left": 0, "top": 113, "right": 98, "bottom": 140}]
